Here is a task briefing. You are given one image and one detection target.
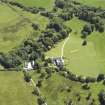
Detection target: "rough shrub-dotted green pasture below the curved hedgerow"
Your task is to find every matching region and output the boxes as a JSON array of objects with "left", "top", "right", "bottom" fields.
[{"left": 32, "top": 72, "right": 104, "bottom": 105}]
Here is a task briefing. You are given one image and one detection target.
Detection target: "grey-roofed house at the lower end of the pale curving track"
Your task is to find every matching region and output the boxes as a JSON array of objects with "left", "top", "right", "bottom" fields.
[{"left": 52, "top": 57, "right": 64, "bottom": 68}]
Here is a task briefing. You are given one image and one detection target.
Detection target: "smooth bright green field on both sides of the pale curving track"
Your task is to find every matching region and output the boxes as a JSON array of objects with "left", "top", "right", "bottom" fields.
[{"left": 46, "top": 18, "right": 105, "bottom": 76}]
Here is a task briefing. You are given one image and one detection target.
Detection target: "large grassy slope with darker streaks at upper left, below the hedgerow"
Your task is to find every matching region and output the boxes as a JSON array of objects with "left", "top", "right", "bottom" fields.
[{"left": 0, "top": 4, "right": 48, "bottom": 53}]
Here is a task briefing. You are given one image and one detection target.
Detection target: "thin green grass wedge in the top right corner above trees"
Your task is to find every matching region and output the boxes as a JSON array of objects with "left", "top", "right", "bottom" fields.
[{"left": 76, "top": 0, "right": 105, "bottom": 9}]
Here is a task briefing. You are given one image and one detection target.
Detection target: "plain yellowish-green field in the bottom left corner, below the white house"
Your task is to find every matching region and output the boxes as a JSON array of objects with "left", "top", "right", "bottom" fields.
[{"left": 0, "top": 71, "right": 37, "bottom": 105}]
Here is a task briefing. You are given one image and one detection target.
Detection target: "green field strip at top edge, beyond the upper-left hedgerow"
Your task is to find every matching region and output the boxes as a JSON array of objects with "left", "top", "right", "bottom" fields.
[{"left": 13, "top": 0, "right": 55, "bottom": 9}]
